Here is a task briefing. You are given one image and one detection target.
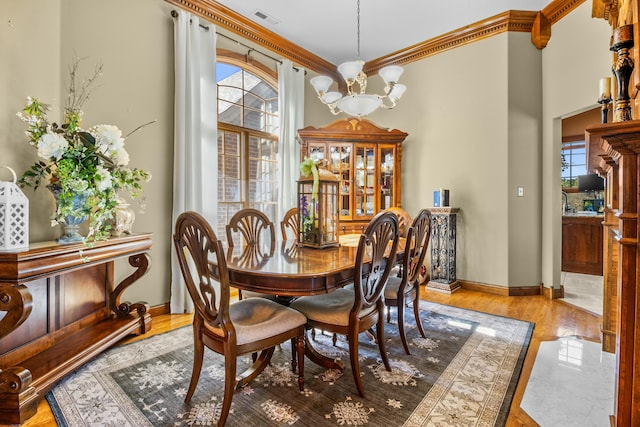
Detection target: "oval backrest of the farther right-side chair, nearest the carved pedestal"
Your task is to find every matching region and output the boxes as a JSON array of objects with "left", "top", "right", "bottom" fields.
[{"left": 402, "top": 209, "right": 431, "bottom": 284}]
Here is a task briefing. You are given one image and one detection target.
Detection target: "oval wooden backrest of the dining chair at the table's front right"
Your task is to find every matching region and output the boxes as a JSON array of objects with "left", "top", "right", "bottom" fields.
[{"left": 352, "top": 211, "right": 399, "bottom": 314}]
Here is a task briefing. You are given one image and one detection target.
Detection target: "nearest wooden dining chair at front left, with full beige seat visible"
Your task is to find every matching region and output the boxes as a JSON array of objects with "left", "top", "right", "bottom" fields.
[{"left": 173, "top": 212, "right": 307, "bottom": 426}]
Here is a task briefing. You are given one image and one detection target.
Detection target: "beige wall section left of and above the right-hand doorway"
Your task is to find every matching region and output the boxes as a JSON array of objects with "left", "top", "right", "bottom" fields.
[{"left": 542, "top": 2, "right": 612, "bottom": 288}]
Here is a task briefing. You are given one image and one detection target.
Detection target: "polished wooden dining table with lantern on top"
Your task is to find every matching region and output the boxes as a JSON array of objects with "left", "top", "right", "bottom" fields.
[{"left": 226, "top": 235, "right": 404, "bottom": 369}]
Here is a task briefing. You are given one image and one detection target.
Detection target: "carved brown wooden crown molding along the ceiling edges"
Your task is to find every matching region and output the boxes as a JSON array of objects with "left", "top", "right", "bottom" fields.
[{"left": 165, "top": 0, "right": 588, "bottom": 74}]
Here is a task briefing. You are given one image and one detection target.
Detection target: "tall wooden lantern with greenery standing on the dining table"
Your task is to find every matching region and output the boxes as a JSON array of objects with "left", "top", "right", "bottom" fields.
[{"left": 298, "top": 169, "right": 340, "bottom": 248}]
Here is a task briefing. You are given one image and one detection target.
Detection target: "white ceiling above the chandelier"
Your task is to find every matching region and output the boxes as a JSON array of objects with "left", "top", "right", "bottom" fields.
[{"left": 217, "top": 0, "right": 551, "bottom": 64}]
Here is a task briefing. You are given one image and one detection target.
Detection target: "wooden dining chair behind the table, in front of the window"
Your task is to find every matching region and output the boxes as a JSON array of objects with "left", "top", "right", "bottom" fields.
[{"left": 226, "top": 208, "right": 276, "bottom": 299}]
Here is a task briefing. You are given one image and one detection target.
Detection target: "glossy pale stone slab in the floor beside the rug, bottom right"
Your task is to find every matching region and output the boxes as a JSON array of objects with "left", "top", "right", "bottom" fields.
[{"left": 520, "top": 337, "right": 615, "bottom": 427}]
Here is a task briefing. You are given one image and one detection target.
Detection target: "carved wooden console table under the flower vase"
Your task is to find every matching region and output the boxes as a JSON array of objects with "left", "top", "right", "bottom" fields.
[{"left": 0, "top": 234, "right": 151, "bottom": 424}]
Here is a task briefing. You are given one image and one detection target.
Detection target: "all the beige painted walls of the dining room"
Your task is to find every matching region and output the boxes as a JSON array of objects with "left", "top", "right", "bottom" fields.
[{"left": 0, "top": 0, "right": 611, "bottom": 305}]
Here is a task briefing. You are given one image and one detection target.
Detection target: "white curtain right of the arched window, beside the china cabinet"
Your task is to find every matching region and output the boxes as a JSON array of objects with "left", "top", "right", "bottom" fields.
[{"left": 277, "top": 60, "right": 304, "bottom": 227}]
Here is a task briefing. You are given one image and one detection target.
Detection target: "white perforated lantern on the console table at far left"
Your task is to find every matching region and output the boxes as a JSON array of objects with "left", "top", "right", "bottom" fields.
[{"left": 0, "top": 166, "right": 29, "bottom": 252}]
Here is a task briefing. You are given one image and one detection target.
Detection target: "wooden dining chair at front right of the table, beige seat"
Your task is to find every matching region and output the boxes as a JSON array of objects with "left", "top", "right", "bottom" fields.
[{"left": 290, "top": 212, "right": 399, "bottom": 397}]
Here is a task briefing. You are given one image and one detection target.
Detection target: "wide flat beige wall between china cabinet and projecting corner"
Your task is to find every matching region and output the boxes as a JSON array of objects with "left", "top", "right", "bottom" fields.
[{"left": 364, "top": 34, "right": 509, "bottom": 286}]
